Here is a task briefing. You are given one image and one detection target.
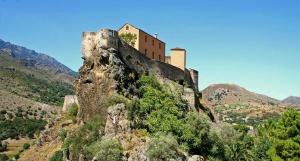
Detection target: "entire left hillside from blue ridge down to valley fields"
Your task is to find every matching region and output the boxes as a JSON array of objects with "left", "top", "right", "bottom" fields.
[{"left": 0, "top": 40, "right": 76, "bottom": 160}]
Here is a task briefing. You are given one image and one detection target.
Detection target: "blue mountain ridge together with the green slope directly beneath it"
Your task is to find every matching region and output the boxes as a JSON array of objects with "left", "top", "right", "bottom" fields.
[{"left": 0, "top": 41, "right": 75, "bottom": 106}]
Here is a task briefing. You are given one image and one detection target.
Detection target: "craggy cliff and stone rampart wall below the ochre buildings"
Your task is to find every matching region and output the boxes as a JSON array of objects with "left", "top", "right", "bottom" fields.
[{"left": 75, "top": 29, "right": 198, "bottom": 121}]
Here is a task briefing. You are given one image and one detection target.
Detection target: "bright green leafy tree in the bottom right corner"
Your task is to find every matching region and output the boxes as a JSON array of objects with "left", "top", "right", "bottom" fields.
[{"left": 255, "top": 109, "right": 300, "bottom": 161}]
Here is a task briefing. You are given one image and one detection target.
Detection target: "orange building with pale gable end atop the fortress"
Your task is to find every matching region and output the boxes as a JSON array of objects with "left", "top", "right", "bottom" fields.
[{"left": 118, "top": 23, "right": 166, "bottom": 62}]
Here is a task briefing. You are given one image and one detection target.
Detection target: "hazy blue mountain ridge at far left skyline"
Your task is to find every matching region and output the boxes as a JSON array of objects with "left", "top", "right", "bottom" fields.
[{"left": 0, "top": 39, "right": 76, "bottom": 76}]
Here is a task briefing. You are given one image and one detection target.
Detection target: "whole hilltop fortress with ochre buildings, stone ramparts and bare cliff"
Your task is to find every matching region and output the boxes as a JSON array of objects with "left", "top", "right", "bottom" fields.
[{"left": 75, "top": 25, "right": 206, "bottom": 121}]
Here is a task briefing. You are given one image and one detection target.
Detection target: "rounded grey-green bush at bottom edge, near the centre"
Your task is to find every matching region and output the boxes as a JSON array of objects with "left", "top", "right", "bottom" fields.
[{"left": 146, "top": 134, "right": 179, "bottom": 161}]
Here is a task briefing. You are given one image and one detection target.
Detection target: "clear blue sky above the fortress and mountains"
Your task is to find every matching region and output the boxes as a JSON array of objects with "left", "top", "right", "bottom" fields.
[{"left": 0, "top": 0, "right": 300, "bottom": 99}]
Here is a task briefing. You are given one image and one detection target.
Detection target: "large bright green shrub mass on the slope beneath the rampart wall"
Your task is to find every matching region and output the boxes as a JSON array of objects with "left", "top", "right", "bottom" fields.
[{"left": 128, "top": 75, "right": 216, "bottom": 154}]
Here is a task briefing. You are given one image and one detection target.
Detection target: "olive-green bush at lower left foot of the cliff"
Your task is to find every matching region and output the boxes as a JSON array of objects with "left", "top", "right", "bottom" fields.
[{"left": 63, "top": 116, "right": 105, "bottom": 161}]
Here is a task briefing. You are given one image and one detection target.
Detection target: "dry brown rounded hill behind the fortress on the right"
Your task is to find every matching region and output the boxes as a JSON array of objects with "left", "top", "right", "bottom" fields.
[{"left": 201, "top": 84, "right": 294, "bottom": 125}]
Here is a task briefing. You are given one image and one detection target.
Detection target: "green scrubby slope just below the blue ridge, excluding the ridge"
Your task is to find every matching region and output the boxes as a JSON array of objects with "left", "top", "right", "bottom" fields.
[{"left": 0, "top": 47, "right": 75, "bottom": 106}]
